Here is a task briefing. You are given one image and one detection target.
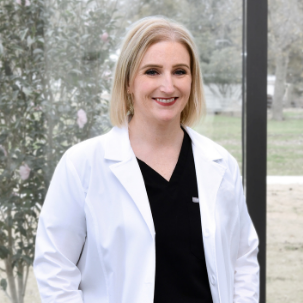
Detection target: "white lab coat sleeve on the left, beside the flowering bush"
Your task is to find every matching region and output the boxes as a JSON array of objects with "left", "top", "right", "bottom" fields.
[{"left": 34, "top": 153, "right": 86, "bottom": 303}]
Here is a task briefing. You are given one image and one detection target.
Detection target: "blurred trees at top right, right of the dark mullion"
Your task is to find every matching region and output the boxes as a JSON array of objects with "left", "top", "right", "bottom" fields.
[{"left": 268, "top": 0, "right": 303, "bottom": 120}]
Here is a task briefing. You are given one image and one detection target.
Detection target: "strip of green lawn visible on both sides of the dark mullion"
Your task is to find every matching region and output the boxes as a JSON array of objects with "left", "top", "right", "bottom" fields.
[{"left": 195, "top": 110, "right": 303, "bottom": 176}]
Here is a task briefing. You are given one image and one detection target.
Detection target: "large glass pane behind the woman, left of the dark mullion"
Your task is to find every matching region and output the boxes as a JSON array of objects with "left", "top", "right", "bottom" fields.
[{"left": 0, "top": 0, "right": 242, "bottom": 303}]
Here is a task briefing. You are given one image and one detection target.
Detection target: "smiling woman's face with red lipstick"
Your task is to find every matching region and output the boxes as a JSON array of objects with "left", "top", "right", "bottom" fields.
[{"left": 129, "top": 41, "right": 192, "bottom": 124}]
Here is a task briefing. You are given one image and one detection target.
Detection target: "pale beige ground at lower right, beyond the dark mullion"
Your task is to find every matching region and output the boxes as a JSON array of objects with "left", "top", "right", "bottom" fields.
[{"left": 266, "top": 184, "right": 303, "bottom": 303}]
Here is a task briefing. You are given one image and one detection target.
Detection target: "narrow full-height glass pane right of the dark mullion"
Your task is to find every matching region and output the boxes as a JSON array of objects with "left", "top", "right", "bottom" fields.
[{"left": 267, "top": 0, "right": 303, "bottom": 303}]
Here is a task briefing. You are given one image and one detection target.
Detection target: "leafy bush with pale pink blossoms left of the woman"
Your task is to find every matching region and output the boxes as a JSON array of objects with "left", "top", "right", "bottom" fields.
[{"left": 0, "top": 0, "right": 117, "bottom": 303}]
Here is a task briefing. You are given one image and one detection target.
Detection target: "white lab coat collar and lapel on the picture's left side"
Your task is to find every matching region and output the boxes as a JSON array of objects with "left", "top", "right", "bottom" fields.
[{"left": 105, "top": 127, "right": 155, "bottom": 238}]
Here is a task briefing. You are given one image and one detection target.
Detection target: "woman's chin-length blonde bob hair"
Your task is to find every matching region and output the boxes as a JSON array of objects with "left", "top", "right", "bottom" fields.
[{"left": 110, "top": 16, "right": 205, "bottom": 127}]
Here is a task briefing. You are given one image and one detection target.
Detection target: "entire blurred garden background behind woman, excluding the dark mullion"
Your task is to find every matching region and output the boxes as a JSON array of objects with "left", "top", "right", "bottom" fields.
[{"left": 0, "top": 0, "right": 303, "bottom": 303}]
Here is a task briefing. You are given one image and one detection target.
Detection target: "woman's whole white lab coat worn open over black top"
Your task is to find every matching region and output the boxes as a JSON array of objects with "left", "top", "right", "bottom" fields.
[{"left": 34, "top": 127, "right": 259, "bottom": 303}]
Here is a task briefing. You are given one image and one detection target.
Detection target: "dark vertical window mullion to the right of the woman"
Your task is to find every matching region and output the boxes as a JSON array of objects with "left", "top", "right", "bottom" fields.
[{"left": 242, "top": 0, "right": 268, "bottom": 303}]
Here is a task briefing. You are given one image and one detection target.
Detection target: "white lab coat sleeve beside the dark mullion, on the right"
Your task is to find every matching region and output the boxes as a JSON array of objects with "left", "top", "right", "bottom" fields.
[{"left": 234, "top": 159, "right": 259, "bottom": 303}]
